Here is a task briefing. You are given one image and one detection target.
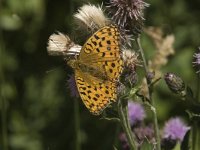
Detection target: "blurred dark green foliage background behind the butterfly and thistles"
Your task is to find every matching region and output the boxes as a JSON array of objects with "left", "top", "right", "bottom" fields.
[{"left": 0, "top": 0, "right": 200, "bottom": 150}]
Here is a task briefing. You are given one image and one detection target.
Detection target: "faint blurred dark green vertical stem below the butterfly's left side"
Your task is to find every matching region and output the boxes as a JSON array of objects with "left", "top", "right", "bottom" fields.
[{"left": 74, "top": 98, "right": 81, "bottom": 150}]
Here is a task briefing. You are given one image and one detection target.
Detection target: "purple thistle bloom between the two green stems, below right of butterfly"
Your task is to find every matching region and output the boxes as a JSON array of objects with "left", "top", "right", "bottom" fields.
[{"left": 128, "top": 101, "right": 146, "bottom": 126}]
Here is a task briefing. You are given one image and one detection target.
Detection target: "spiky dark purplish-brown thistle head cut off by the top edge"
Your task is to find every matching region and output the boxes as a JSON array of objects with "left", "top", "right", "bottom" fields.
[{"left": 107, "top": 0, "right": 149, "bottom": 34}]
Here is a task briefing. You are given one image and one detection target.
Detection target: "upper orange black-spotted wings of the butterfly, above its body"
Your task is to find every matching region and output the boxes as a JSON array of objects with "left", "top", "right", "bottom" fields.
[{"left": 79, "top": 25, "right": 123, "bottom": 80}]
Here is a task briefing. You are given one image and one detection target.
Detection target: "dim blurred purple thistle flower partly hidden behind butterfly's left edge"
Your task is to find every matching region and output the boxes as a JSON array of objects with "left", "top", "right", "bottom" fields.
[{"left": 67, "top": 75, "right": 79, "bottom": 97}]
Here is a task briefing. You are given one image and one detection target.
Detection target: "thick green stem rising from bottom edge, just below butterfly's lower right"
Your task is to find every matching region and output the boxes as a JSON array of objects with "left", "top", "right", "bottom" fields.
[{"left": 118, "top": 100, "right": 137, "bottom": 150}]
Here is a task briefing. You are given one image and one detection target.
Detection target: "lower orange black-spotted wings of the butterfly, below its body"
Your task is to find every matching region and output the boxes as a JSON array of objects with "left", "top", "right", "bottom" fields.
[{"left": 75, "top": 70, "right": 116, "bottom": 115}]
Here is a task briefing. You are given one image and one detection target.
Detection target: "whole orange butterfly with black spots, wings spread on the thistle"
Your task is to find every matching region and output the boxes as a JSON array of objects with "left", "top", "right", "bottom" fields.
[{"left": 68, "top": 25, "right": 123, "bottom": 115}]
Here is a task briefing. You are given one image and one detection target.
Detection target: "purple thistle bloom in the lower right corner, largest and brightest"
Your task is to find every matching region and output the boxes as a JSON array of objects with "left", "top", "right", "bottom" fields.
[{"left": 163, "top": 117, "right": 190, "bottom": 142}]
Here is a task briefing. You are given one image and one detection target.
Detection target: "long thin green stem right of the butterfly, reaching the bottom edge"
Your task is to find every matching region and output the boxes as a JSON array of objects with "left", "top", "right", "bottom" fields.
[{"left": 136, "top": 37, "right": 161, "bottom": 150}]
